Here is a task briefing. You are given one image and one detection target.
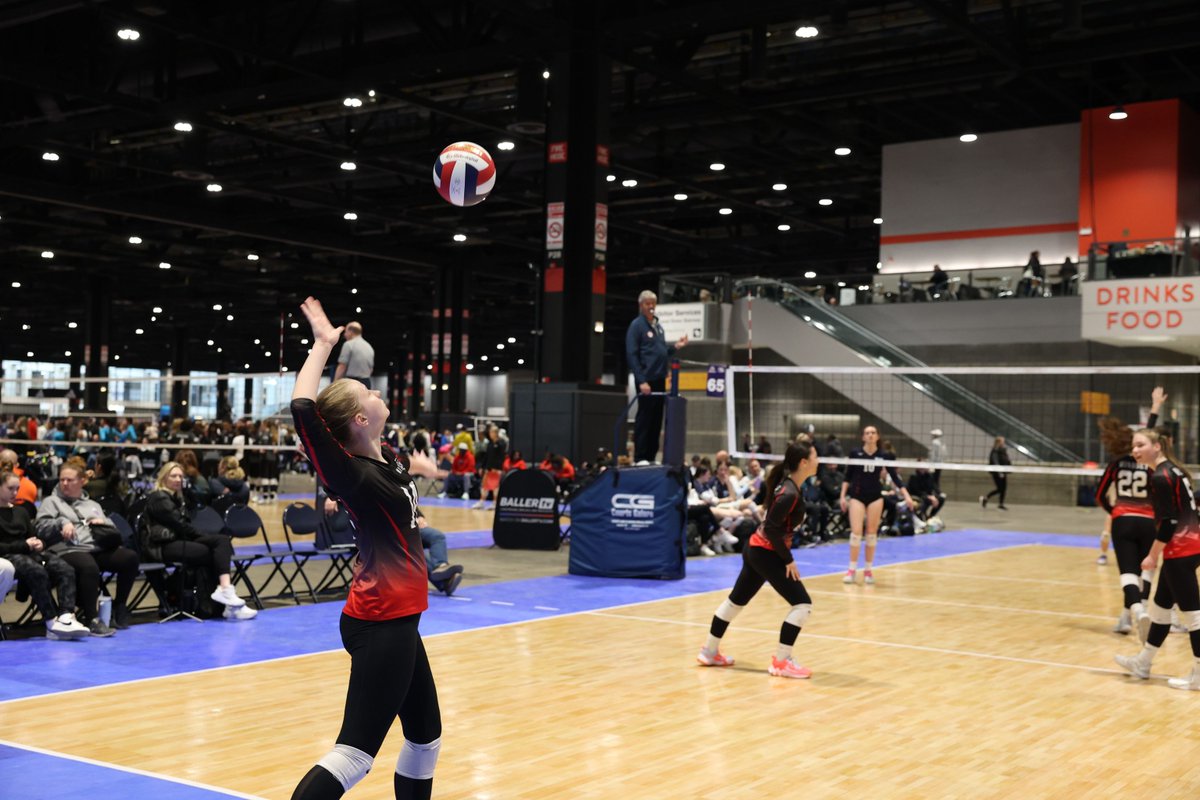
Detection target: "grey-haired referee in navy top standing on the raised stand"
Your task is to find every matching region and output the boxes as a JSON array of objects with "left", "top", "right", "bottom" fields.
[{"left": 625, "top": 289, "right": 688, "bottom": 463}]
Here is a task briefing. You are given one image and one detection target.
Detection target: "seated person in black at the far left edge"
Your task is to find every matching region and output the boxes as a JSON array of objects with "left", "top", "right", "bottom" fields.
[{"left": 0, "top": 469, "right": 90, "bottom": 640}]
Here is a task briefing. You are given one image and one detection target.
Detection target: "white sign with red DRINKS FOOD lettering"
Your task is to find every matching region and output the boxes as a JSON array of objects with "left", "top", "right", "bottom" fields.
[{"left": 1080, "top": 277, "right": 1200, "bottom": 344}]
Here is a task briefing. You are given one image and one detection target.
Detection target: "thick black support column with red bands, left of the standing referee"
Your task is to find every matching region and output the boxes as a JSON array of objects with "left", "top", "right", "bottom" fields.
[{"left": 542, "top": 0, "right": 612, "bottom": 383}]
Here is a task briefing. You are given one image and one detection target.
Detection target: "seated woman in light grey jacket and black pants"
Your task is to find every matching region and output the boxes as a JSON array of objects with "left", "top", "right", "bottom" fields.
[{"left": 34, "top": 457, "right": 139, "bottom": 637}]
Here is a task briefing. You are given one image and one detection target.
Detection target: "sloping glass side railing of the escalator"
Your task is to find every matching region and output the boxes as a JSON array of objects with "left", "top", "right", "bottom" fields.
[{"left": 736, "top": 278, "right": 1081, "bottom": 464}]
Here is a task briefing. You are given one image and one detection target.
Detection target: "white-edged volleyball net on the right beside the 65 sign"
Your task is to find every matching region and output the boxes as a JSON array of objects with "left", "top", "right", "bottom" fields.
[{"left": 725, "top": 366, "right": 1200, "bottom": 482}]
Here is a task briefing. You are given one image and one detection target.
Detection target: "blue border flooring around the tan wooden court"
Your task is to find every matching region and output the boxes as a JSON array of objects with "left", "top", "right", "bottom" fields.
[{"left": 0, "top": 530, "right": 1094, "bottom": 800}]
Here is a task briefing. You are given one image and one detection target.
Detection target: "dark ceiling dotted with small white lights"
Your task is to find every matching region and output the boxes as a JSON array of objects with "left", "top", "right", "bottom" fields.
[{"left": 0, "top": 0, "right": 1200, "bottom": 381}]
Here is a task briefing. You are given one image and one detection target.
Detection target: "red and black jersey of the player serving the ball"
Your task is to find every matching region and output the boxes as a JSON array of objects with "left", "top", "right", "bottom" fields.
[{"left": 292, "top": 398, "right": 430, "bottom": 621}]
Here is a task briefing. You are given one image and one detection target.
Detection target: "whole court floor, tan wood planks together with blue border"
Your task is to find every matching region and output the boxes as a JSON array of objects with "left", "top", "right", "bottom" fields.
[{"left": 0, "top": 504, "right": 1200, "bottom": 799}]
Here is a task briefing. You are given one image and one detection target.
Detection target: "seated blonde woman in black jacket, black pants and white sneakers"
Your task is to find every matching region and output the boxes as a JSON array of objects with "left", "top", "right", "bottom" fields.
[{"left": 140, "top": 461, "right": 258, "bottom": 620}]
